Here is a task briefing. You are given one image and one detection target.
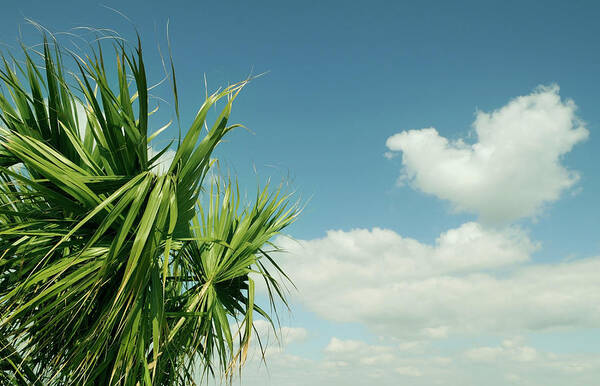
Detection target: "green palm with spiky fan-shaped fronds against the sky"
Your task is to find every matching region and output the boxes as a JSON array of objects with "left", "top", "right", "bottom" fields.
[{"left": 0, "top": 30, "right": 299, "bottom": 385}]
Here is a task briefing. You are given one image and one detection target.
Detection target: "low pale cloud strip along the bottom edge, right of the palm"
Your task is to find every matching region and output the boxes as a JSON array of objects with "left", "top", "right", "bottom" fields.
[{"left": 231, "top": 337, "right": 600, "bottom": 386}]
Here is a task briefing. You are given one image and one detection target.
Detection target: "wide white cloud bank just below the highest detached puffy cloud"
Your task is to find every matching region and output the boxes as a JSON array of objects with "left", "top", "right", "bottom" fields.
[{"left": 278, "top": 223, "right": 600, "bottom": 339}]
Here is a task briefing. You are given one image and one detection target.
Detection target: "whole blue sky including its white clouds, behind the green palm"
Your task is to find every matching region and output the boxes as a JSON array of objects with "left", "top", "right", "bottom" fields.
[{"left": 0, "top": 1, "right": 600, "bottom": 385}]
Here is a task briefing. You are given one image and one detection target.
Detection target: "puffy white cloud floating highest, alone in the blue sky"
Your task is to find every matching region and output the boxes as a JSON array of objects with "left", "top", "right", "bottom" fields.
[{"left": 386, "top": 86, "right": 588, "bottom": 223}]
